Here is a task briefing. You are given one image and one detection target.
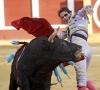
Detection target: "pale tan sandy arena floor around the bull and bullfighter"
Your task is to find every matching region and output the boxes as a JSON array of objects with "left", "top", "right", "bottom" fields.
[{"left": 0, "top": 40, "right": 100, "bottom": 90}]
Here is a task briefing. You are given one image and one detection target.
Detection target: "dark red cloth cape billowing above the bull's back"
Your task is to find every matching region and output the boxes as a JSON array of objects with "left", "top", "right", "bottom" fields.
[{"left": 11, "top": 17, "right": 57, "bottom": 37}]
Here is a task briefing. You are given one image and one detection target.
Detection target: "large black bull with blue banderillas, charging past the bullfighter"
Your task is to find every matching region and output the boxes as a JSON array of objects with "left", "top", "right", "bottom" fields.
[{"left": 9, "top": 36, "right": 81, "bottom": 90}]
